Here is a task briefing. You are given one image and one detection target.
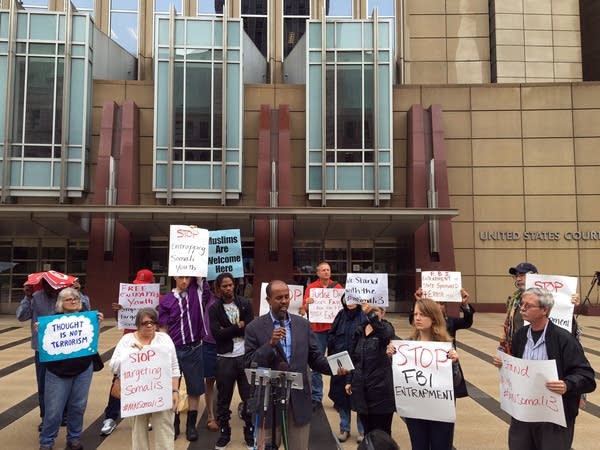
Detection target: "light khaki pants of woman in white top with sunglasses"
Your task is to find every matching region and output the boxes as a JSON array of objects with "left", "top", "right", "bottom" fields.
[{"left": 131, "top": 409, "right": 175, "bottom": 450}]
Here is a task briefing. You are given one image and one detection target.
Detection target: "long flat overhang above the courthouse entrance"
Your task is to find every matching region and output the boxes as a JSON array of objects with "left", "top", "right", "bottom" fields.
[{"left": 0, "top": 205, "right": 458, "bottom": 240}]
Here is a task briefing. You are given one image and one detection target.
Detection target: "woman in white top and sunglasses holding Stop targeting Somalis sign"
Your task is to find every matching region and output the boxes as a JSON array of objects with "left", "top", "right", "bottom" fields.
[{"left": 109, "top": 308, "right": 180, "bottom": 450}]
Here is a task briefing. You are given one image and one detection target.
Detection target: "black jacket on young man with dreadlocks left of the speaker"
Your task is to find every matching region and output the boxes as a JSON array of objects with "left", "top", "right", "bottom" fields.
[{"left": 208, "top": 295, "right": 254, "bottom": 355}]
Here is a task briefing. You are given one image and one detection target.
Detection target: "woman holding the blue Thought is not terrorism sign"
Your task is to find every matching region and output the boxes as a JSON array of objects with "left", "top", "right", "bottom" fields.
[{"left": 35, "top": 288, "right": 103, "bottom": 450}]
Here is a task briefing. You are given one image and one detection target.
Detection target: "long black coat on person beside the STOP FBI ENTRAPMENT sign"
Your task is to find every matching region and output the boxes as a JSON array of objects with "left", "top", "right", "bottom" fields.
[{"left": 347, "top": 312, "right": 396, "bottom": 414}]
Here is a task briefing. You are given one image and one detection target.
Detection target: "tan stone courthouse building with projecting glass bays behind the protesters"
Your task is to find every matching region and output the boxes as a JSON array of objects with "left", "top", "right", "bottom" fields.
[{"left": 0, "top": 0, "right": 600, "bottom": 312}]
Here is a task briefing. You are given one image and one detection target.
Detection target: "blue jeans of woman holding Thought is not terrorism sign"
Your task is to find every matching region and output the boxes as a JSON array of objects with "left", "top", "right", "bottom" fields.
[{"left": 40, "top": 362, "right": 93, "bottom": 447}]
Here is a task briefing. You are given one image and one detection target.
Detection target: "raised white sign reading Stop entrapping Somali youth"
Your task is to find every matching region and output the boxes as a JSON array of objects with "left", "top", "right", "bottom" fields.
[{"left": 169, "top": 225, "right": 208, "bottom": 277}]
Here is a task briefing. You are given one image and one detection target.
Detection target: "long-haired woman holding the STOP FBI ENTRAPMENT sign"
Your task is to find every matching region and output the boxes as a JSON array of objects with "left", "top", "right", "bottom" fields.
[{"left": 405, "top": 298, "right": 462, "bottom": 450}]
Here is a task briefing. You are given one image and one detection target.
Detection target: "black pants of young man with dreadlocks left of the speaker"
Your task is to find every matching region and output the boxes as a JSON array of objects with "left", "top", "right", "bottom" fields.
[{"left": 215, "top": 355, "right": 250, "bottom": 426}]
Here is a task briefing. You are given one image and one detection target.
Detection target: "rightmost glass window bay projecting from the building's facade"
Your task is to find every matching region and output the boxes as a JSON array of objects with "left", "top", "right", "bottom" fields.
[{"left": 306, "top": 20, "right": 393, "bottom": 194}]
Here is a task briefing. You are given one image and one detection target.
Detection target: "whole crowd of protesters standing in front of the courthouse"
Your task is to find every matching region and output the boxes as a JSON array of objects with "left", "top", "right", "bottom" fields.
[{"left": 17, "top": 262, "right": 596, "bottom": 450}]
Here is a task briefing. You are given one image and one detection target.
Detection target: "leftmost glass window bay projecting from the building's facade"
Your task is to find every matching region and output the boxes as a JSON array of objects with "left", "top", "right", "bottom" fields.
[{"left": 0, "top": 12, "right": 93, "bottom": 196}]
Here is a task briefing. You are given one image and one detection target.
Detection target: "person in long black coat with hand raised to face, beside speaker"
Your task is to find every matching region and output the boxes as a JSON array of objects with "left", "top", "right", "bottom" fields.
[{"left": 345, "top": 302, "right": 396, "bottom": 435}]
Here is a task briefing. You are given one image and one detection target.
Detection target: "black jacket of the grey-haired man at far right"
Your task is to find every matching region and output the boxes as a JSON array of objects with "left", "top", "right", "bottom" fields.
[{"left": 512, "top": 321, "right": 596, "bottom": 422}]
